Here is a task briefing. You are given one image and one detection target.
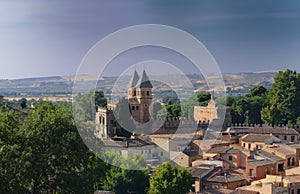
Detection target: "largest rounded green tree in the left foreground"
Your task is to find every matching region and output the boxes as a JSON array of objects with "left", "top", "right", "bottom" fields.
[{"left": 21, "top": 103, "right": 103, "bottom": 193}]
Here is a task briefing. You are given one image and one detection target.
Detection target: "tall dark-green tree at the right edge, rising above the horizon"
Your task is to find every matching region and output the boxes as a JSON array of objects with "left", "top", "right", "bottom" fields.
[{"left": 262, "top": 70, "right": 300, "bottom": 124}]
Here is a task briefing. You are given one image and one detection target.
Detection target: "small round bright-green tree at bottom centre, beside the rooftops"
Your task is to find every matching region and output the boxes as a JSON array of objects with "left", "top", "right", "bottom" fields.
[{"left": 148, "top": 163, "right": 193, "bottom": 194}]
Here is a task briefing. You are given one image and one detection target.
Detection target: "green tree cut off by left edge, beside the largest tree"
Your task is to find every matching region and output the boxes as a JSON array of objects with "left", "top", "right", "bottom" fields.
[{"left": 0, "top": 110, "right": 29, "bottom": 193}]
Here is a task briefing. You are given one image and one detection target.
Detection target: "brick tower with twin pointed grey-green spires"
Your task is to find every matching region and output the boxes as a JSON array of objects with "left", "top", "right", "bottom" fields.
[{"left": 128, "top": 70, "right": 153, "bottom": 123}]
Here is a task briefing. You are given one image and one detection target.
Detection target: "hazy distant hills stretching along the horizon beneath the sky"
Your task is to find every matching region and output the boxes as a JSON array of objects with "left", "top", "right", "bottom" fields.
[{"left": 0, "top": 71, "right": 278, "bottom": 97}]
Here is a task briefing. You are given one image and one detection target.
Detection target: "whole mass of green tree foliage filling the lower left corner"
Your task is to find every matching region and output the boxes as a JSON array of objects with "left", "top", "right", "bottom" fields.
[{"left": 0, "top": 102, "right": 105, "bottom": 193}]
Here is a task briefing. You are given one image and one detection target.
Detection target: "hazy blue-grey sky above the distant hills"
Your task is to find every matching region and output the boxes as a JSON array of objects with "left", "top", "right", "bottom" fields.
[{"left": 0, "top": 0, "right": 300, "bottom": 79}]
